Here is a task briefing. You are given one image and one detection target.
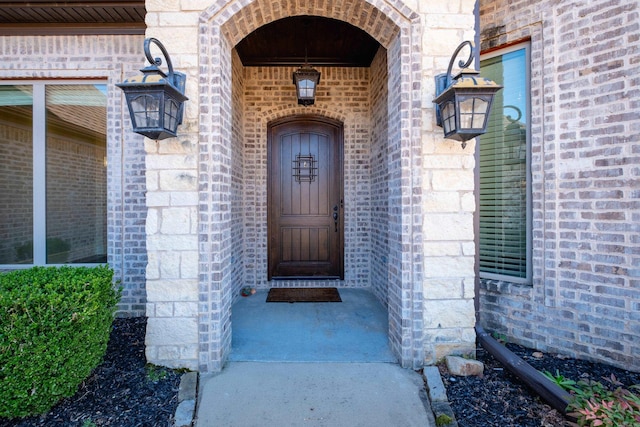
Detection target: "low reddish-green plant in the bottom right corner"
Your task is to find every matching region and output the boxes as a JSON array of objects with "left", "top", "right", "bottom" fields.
[{"left": 567, "top": 375, "right": 640, "bottom": 427}]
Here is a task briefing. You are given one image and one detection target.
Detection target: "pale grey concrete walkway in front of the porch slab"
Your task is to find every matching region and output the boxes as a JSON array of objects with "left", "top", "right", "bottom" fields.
[{"left": 195, "top": 362, "right": 435, "bottom": 427}]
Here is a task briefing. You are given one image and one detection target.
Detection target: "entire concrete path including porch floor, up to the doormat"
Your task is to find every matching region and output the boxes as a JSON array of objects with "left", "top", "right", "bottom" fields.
[{"left": 196, "top": 289, "right": 435, "bottom": 427}]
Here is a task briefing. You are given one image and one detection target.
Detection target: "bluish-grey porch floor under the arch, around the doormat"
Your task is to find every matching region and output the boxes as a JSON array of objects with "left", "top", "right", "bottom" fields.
[{"left": 229, "top": 288, "right": 397, "bottom": 363}]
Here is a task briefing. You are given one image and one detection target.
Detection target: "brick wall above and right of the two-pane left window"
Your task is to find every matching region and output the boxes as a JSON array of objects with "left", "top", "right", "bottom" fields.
[{"left": 0, "top": 36, "right": 147, "bottom": 316}]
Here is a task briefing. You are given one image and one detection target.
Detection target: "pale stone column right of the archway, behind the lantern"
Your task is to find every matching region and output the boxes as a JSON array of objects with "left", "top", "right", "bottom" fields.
[{"left": 414, "top": 1, "right": 476, "bottom": 364}]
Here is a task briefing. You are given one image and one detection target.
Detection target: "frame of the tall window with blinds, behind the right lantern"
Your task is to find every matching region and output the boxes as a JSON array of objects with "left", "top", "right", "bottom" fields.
[{"left": 477, "top": 40, "right": 533, "bottom": 285}]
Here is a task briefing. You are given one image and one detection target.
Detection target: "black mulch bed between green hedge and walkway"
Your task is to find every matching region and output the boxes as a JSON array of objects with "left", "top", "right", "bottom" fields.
[{"left": 0, "top": 318, "right": 181, "bottom": 427}]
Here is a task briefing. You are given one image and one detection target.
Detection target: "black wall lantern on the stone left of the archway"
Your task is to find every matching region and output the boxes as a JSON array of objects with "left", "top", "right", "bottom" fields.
[{"left": 116, "top": 38, "right": 189, "bottom": 140}]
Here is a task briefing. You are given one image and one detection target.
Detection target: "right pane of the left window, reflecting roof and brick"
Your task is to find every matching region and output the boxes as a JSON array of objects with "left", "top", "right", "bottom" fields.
[{"left": 46, "top": 85, "right": 107, "bottom": 264}]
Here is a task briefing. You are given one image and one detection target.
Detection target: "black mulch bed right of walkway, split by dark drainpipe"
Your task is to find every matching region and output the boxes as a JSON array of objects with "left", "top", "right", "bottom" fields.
[{"left": 439, "top": 343, "right": 640, "bottom": 427}]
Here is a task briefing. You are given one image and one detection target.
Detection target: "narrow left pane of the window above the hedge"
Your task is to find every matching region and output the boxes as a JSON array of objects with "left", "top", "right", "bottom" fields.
[{"left": 0, "top": 86, "right": 33, "bottom": 264}]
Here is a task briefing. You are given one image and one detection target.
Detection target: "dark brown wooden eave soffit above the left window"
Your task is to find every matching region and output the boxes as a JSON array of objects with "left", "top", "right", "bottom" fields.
[{"left": 0, "top": 0, "right": 146, "bottom": 35}]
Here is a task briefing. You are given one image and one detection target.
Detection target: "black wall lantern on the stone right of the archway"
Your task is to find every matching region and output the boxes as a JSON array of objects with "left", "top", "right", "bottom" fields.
[{"left": 433, "top": 41, "right": 502, "bottom": 148}]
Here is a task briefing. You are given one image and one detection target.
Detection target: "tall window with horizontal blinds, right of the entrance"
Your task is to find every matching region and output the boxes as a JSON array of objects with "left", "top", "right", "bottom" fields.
[{"left": 479, "top": 45, "right": 531, "bottom": 283}]
